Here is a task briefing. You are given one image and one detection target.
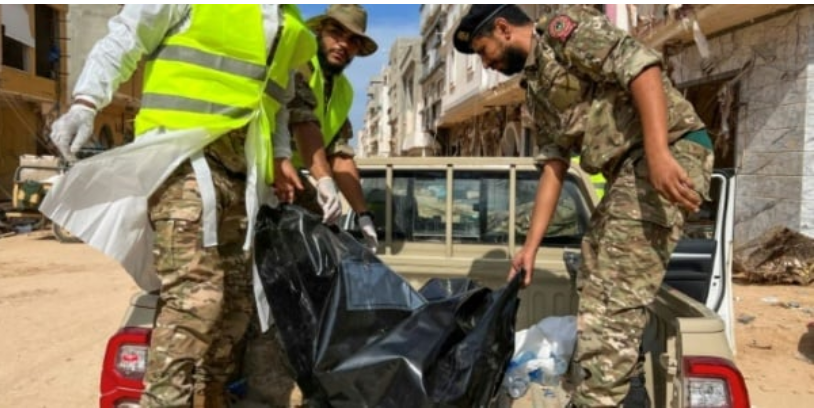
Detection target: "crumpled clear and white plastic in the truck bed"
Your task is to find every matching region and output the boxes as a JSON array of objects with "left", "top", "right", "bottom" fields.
[{"left": 503, "top": 316, "right": 577, "bottom": 398}]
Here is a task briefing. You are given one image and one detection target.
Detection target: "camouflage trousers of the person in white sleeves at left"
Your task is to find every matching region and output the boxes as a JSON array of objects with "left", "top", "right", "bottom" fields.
[{"left": 141, "top": 156, "right": 254, "bottom": 408}]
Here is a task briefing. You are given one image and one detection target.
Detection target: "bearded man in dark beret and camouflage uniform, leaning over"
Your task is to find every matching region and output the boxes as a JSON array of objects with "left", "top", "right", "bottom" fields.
[{"left": 454, "top": 5, "right": 713, "bottom": 407}]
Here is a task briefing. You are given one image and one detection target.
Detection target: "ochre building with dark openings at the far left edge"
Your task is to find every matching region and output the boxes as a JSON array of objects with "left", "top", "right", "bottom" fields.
[{"left": 0, "top": 4, "right": 69, "bottom": 201}]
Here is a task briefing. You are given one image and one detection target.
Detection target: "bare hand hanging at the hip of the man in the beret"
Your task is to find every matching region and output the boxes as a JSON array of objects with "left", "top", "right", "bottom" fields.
[{"left": 647, "top": 151, "right": 701, "bottom": 212}]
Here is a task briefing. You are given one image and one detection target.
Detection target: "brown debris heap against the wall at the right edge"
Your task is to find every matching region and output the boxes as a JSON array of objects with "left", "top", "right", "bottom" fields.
[{"left": 732, "top": 227, "right": 814, "bottom": 286}]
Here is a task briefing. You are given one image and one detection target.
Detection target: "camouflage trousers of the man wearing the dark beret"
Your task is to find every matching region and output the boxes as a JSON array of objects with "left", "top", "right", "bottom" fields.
[{"left": 572, "top": 135, "right": 713, "bottom": 407}]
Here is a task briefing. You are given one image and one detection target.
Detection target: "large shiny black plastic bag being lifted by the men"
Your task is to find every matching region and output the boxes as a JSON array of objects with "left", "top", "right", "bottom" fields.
[{"left": 255, "top": 205, "right": 521, "bottom": 408}]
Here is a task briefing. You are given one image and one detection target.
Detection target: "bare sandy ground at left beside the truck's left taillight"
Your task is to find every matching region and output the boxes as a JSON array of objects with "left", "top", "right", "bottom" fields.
[{"left": 0, "top": 234, "right": 137, "bottom": 408}]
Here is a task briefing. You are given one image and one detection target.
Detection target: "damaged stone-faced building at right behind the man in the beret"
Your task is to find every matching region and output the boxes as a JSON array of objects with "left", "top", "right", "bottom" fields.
[{"left": 628, "top": 4, "right": 814, "bottom": 239}]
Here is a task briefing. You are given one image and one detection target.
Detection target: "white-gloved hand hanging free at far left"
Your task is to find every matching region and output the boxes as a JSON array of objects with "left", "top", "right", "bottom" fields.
[{"left": 51, "top": 103, "right": 96, "bottom": 161}]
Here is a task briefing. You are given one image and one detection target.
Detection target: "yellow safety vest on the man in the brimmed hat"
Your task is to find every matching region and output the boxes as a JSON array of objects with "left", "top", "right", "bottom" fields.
[{"left": 292, "top": 56, "right": 353, "bottom": 168}]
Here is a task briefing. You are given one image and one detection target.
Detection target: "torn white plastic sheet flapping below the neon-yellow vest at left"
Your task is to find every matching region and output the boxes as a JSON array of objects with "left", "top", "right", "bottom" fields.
[{"left": 40, "top": 129, "right": 218, "bottom": 291}]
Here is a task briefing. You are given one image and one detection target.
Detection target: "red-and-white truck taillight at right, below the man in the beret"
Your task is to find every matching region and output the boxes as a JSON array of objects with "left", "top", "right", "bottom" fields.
[{"left": 684, "top": 357, "right": 749, "bottom": 408}]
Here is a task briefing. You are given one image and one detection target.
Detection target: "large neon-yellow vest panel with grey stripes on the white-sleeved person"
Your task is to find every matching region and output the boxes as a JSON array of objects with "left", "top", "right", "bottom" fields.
[{"left": 136, "top": 4, "right": 268, "bottom": 135}]
